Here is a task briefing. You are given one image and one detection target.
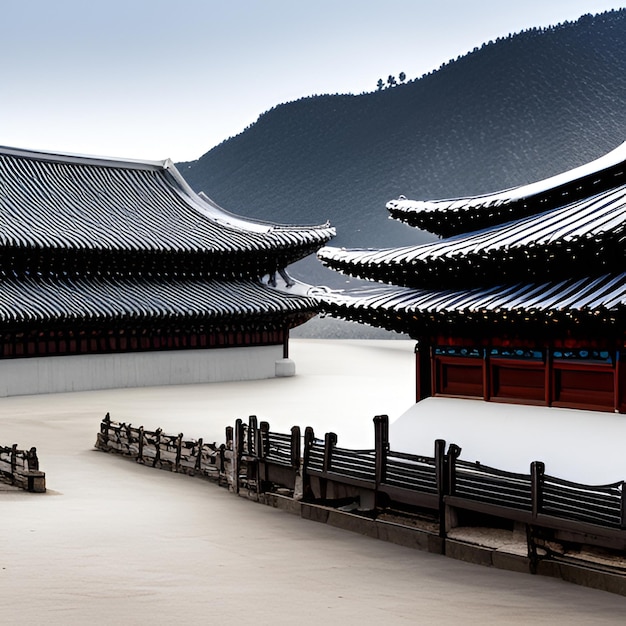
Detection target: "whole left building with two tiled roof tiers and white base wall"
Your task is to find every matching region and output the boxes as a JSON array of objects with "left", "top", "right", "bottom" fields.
[{"left": 0, "top": 148, "right": 334, "bottom": 396}]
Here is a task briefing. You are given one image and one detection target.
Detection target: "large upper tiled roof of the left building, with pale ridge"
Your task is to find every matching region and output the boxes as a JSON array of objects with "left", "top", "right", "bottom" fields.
[{"left": 0, "top": 148, "right": 334, "bottom": 274}]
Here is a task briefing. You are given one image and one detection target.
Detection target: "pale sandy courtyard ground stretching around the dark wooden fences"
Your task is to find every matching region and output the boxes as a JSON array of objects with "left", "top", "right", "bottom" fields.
[{"left": 0, "top": 340, "right": 626, "bottom": 625}]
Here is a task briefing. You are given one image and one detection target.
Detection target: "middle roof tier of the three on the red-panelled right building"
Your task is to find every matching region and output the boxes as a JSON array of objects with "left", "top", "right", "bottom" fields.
[{"left": 318, "top": 180, "right": 626, "bottom": 287}]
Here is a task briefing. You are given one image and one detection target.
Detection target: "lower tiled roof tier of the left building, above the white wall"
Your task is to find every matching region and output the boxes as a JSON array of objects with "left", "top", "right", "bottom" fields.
[{"left": 0, "top": 275, "right": 317, "bottom": 329}]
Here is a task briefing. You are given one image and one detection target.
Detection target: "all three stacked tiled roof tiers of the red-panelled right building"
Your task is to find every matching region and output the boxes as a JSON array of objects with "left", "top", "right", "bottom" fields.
[{"left": 318, "top": 143, "right": 626, "bottom": 341}]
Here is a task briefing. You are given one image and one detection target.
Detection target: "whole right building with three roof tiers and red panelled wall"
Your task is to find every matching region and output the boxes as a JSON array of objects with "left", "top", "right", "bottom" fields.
[{"left": 318, "top": 143, "right": 626, "bottom": 412}]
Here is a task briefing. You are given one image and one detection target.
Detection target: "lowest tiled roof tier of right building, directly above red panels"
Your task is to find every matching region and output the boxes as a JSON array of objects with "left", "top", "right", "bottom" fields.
[{"left": 317, "top": 273, "right": 626, "bottom": 336}]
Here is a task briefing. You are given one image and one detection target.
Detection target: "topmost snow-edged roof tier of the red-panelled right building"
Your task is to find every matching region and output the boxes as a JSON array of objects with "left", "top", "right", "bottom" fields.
[{"left": 387, "top": 142, "right": 626, "bottom": 237}]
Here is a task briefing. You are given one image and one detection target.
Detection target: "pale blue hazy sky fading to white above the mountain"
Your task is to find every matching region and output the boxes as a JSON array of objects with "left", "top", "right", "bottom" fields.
[{"left": 0, "top": 0, "right": 626, "bottom": 161}]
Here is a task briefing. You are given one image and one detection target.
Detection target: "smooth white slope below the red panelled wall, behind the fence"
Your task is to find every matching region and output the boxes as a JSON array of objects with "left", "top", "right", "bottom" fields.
[{"left": 389, "top": 398, "right": 626, "bottom": 485}]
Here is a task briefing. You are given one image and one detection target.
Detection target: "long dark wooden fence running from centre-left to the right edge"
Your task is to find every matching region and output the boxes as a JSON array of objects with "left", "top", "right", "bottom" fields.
[{"left": 96, "top": 415, "right": 626, "bottom": 550}]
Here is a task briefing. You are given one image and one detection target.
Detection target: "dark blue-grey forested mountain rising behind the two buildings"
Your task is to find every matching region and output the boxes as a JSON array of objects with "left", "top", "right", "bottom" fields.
[{"left": 179, "top": 9, "right": 626, "bottom": 296}]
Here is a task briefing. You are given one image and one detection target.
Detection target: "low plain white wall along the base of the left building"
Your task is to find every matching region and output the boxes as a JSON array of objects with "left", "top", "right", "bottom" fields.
[{"left": 0, "top": 345, "right": 283, "bottom": 396}]
